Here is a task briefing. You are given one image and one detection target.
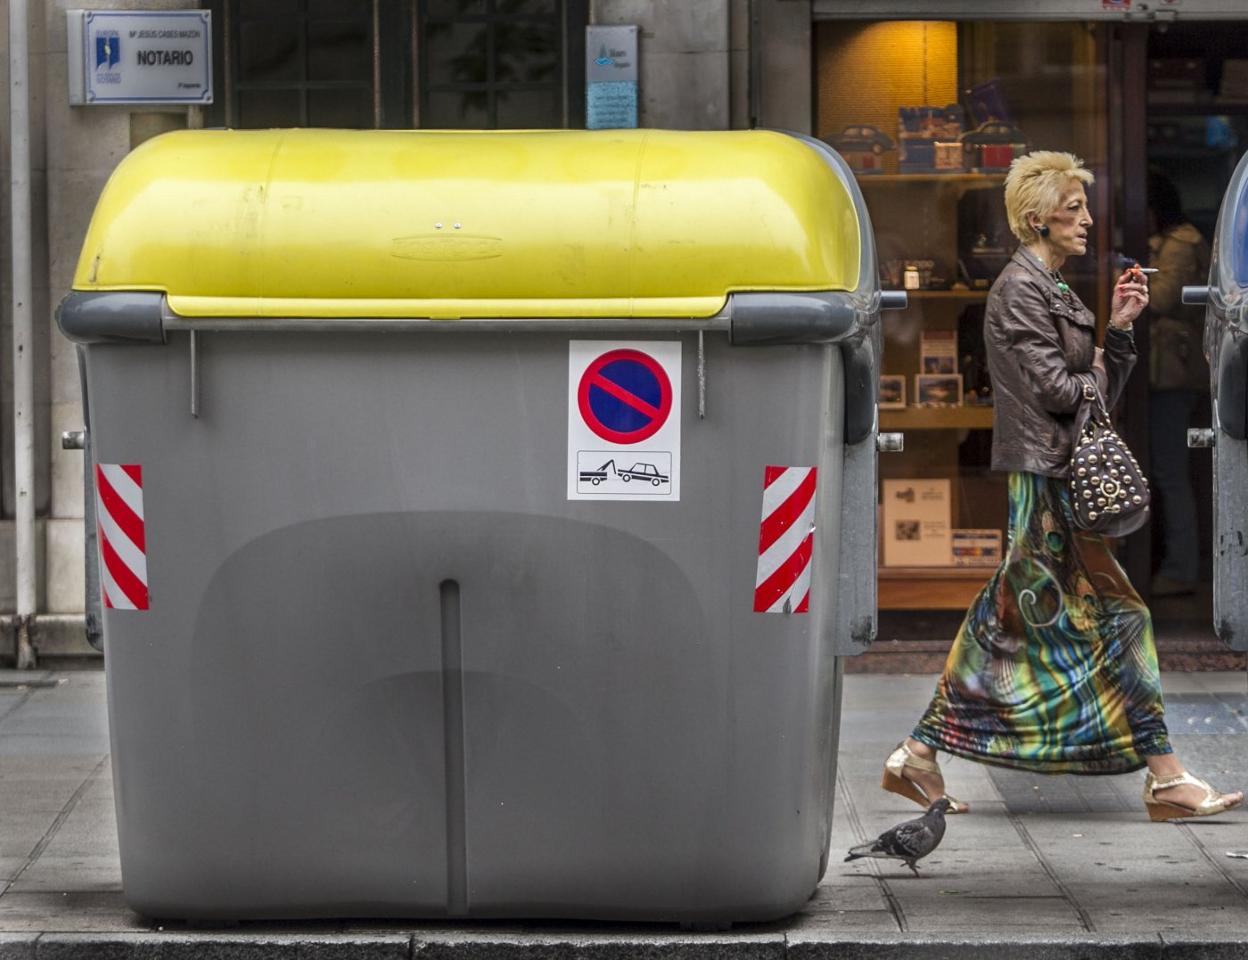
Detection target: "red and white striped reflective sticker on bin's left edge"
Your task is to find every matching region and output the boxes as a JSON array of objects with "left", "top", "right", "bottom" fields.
[{"left": 95, "top": 463, "right": 147, "bottom": 610}]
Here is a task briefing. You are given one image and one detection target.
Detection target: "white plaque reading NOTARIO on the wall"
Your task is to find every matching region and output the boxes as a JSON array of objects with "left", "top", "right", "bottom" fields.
[{"left": 66, "top": 10, "right": 212, "bottom": 104}]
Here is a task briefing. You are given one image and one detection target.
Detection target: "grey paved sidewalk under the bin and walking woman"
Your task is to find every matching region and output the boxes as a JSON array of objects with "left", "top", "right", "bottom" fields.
[{"left": 0, "top": 670, "right": 1248, "bottom": 960}]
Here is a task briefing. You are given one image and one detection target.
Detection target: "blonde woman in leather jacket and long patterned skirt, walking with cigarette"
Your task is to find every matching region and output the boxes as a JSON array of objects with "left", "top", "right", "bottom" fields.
[{"left": 884, "top": 151, "right": 1243, "bottom": 820}]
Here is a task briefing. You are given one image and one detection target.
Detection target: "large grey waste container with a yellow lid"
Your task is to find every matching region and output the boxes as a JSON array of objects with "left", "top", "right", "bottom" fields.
[{"left": 59, "top": 131, "right": 903, "bottom": 923}]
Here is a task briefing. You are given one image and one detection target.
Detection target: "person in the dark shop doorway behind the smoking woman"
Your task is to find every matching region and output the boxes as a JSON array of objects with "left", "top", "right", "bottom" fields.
[{"left": 1148, "top": 172, "right": 1209, "bottom": 597}]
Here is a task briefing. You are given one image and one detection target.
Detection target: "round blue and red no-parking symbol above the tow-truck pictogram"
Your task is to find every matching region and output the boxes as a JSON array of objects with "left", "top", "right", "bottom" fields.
[{"left": 577, "top": 350, "right": 671, "bottom": 443}]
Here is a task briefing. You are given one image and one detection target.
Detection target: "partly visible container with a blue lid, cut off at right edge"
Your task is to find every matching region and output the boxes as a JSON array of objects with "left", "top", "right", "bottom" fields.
[{"left": 1183, "top": 155, "right": 1248, "bottom": 650}]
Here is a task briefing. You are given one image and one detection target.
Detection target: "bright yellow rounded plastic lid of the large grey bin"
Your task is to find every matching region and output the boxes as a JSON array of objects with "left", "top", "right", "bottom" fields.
[{"left": 74, "top": 130, "right": 862, "bottom": 318}]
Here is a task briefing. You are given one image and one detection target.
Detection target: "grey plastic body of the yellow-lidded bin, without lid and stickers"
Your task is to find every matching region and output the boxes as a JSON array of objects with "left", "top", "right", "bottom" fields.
[{"left": 62, "top": 129, "right": 893, "bottom": 921}]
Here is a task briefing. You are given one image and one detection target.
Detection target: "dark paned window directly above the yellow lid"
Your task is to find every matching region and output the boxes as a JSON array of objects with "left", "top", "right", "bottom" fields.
[{"left": 205, "top": 0, "right": 588, "bottom": 129}]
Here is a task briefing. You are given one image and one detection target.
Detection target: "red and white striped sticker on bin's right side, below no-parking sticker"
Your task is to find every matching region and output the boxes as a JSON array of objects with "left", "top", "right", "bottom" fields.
[{"left": 754, "top": 467, "right": 816, "bottom": 613}]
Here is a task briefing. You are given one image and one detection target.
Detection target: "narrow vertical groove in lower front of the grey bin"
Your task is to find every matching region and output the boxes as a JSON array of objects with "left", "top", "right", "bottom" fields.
[{"left": 438, "top": 580, "right": 468, "bottom": 916}]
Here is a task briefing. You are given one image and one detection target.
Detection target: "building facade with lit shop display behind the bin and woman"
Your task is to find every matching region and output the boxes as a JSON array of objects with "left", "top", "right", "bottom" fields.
[{"left": 0, "top": 0, "right": 1248, "bottom": 658}]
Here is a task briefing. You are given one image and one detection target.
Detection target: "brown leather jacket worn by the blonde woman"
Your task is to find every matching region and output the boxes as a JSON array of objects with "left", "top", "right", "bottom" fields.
[{"left": 983, "top": 247, "right": 1136, "bottom": 477}]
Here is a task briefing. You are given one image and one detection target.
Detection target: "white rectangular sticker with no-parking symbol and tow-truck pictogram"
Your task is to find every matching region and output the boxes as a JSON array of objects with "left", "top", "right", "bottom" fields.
[{"left": 568, "top": 340, "right": 680, "bottom": 501}]
